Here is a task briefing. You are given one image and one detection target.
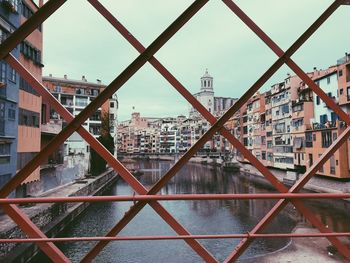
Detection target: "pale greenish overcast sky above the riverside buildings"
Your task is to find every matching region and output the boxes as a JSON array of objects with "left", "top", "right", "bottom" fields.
[{"left": 44, "top": 0, "right": 350, "bottom": 120}]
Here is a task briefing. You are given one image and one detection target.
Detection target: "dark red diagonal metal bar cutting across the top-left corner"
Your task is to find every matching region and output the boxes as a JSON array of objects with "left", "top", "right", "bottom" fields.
[{"left": 0, "top": 0, "right": 67, "bottom": 60}]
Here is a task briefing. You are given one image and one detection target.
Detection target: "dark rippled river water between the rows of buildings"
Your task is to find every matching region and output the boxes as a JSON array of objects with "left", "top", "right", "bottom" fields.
[{"left": 31, "top": 161, "right": 350, "bottom": 263}]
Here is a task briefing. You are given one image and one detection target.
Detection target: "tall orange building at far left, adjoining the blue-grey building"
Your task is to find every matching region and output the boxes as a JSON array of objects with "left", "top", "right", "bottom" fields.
[{"left": 16, "top": 0, "right": 43, "bottom": 196}]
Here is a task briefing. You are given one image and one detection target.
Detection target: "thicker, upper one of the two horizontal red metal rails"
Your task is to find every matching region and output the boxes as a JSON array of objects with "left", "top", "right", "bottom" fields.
[{"left": 0, "top": 193, "right": 350, "bottom": 204}]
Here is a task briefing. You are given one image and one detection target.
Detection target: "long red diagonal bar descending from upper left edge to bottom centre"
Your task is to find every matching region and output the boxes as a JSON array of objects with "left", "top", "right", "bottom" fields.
[{"left": 6, "top": 47, "right": 216, "bottom": 263}]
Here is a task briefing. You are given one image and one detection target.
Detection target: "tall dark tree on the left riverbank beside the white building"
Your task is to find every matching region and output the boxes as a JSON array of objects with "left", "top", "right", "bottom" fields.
[{"left": 90, "top": 112, "right": 114, "bottom": 176}]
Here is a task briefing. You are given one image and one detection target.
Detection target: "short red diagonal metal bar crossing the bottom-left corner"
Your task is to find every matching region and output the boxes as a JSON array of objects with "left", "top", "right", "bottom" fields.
[{"left": 2, "top": 205, "right": 70, "bottom": 263}]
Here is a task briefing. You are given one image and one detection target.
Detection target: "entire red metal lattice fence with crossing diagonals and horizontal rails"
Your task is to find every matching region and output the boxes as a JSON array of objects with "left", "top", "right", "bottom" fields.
[{"left": 0, "top": 0, "right": 350, "bottom": 262}]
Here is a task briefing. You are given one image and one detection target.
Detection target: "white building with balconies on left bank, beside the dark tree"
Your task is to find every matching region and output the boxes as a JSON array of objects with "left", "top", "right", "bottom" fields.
[{"left": 43, "top": 75, "right": 118, "bottom": 169}]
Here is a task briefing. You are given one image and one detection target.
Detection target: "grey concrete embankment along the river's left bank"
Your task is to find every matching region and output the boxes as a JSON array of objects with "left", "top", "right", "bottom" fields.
[{"left": 0, "top": 169, "right": 117, "bottom": 262}]
